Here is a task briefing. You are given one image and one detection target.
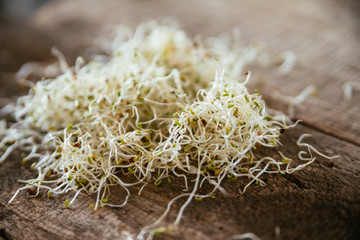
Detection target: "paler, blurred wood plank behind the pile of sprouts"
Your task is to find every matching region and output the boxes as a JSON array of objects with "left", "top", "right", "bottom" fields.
[{"left": 32, "top": 0, "right": 360, "bottom": 145}]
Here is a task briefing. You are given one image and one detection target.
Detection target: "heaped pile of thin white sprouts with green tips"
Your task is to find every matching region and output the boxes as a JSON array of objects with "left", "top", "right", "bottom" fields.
[{"left": 0, "top": 22, "right": 338, "bottom": 238}]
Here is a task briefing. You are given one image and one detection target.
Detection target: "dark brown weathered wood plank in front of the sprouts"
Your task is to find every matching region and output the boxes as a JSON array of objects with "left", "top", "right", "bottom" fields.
[{"left": 0, "top": 126, "right": 360, "bottom": 239}]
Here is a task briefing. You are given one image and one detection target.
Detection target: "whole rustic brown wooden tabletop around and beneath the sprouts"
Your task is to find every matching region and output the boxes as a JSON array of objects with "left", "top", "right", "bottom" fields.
[{"left": 0, "top": 0, "right": 360, "bottom": 239}]
